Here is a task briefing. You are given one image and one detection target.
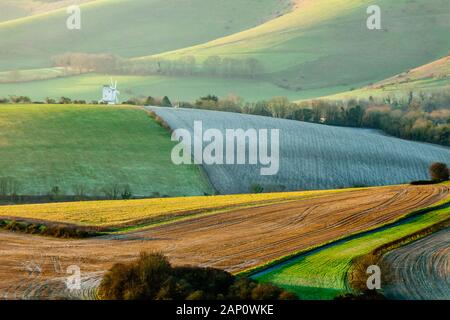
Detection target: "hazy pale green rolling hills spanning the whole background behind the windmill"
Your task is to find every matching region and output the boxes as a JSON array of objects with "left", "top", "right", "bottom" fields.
[{"left": 0, "top": 0, "right": 450, "bottom": 101}]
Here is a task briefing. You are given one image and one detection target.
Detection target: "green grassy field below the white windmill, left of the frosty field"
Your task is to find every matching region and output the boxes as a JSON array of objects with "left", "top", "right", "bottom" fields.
[{"left": 0, "top": 105, "right": 212, "bottom": 196}]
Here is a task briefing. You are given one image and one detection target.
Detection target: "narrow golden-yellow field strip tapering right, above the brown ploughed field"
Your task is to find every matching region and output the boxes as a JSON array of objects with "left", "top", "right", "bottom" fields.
[{"left": 0, "top": 189, "right": 342, "bottom": 226}]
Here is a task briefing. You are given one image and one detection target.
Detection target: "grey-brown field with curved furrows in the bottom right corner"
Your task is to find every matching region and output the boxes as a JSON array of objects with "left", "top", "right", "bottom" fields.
[{"left": 382, "top": 228, "right": 450, "bottom": 300}]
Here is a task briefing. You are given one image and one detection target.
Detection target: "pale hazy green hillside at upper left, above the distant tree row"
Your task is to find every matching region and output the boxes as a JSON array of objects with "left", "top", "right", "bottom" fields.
[{"left": 0, "top": 0, "right": 289, "bottom": 70}]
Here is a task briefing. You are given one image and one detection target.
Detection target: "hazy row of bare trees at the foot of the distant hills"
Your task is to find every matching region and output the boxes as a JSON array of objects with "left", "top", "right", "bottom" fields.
[{"left": 52, "top": 52, "right": 264, "bottom": 79}]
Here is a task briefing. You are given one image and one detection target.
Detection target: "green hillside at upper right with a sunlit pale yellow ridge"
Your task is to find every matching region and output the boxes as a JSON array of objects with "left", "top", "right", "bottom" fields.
[{"left": 149, "top": 0, "right": 450, "bottom": 89}]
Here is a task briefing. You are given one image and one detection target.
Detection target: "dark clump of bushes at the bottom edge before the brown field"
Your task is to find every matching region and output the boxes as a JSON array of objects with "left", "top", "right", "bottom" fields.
[{"left": 99, "top": 253, "right": 297, "bottom": 300}]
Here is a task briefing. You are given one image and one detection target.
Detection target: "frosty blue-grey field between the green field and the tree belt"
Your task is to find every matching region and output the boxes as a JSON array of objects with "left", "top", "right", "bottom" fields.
[{"left": 149, "top": 107, "right": 450, "bottom": 193}]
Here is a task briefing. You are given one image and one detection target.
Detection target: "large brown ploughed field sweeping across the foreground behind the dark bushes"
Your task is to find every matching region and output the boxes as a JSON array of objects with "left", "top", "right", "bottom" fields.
[{"left": 0, "top": 185, "right": 449, "bottom": 299}]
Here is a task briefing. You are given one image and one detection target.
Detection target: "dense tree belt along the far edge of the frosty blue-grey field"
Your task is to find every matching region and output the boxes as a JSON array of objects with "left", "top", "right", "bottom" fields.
[{"left": 180, "top": 92, "right": 450, "bottom": 146}]
